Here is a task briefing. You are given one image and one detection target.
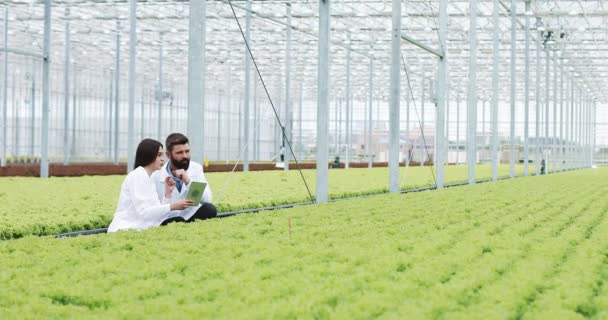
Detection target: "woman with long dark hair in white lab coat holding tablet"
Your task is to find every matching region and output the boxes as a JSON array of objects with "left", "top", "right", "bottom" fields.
[{"left": 108, "top": 139, "right": 192, "bottom": 232}]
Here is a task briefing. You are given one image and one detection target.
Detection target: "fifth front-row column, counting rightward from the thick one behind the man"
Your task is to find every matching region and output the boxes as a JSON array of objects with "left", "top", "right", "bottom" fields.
[{"left": 467, "top": 0, "right": 478, "bottom": 184}]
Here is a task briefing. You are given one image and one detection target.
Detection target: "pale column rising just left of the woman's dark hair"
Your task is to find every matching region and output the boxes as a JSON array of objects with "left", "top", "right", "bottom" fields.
[{"left": 127, "top": 0, "right": 137, "bottom": 173}]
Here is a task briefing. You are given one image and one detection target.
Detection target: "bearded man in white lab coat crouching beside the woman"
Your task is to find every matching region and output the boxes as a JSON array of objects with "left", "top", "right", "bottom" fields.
[{"left": 151, "top": 133, "right": 217, "bottom": 225}]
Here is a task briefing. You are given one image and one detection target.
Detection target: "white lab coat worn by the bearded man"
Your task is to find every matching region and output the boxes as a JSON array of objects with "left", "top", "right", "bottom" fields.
[{"left": 151, "top": 161, "right": 213, "bottom": 220}]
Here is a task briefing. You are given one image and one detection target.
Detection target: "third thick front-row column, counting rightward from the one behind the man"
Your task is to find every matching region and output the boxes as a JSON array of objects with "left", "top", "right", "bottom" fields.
[{"left": 388, "top": 0, "right": 401, "bottom": 193}]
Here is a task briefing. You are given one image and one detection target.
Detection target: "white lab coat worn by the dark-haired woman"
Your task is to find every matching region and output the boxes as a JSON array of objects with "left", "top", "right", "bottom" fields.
[{"left": 108, "top": 167, "right": 171, "bottom": 232}]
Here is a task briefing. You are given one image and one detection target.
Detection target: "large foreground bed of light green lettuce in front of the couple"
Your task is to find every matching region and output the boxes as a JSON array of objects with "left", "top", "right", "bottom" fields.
[{"left": 0, "top": 169, "right": 608, "bottom": 319}]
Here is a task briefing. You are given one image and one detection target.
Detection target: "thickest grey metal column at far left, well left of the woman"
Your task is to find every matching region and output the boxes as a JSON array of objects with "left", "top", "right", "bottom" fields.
[{"left": 40, "top": 0, "right": 51, "bottom": 178}]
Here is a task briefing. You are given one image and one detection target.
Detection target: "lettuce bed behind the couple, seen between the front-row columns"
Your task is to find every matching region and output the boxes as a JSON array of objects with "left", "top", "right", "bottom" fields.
[{"left": 0, "top": 165, "right": 521, "bottom": 240}]
